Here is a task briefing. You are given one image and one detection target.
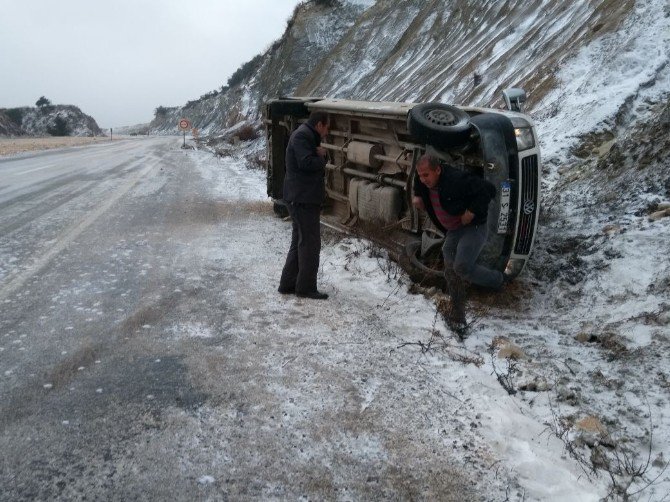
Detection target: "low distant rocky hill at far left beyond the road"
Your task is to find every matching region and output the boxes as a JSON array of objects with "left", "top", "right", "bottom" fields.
[{"left": 0, "top": 105, "right": 103, "bottom": 136}]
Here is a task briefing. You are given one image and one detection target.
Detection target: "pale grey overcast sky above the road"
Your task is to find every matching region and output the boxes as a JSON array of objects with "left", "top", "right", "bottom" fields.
[{"left": 0, "top": 0, "right": 299, "bottom": 128}]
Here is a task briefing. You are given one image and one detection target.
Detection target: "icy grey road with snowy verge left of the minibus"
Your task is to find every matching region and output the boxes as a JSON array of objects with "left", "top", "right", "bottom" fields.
[{"left": 0, "top": 138, "right": 603, "bottom": 501}]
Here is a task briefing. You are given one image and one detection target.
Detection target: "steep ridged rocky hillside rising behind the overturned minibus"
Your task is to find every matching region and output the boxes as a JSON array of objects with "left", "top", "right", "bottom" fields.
[{"left": 146, "top": 0, "right": 667, "bottom": 139}]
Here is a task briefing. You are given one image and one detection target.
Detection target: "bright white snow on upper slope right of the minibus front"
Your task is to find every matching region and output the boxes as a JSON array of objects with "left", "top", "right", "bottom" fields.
[{"left": 534, "top": 0, "right": 670, "bottom": 185}]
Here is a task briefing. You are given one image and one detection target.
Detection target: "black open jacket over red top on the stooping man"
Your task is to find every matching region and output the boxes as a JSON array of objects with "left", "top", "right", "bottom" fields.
[{"left": 414, "top": 164, "right": 496, "bottom": 231}]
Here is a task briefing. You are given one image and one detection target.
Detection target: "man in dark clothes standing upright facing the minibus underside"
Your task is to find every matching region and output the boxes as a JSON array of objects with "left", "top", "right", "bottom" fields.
[{"left": 279, "top": 111, "right": 328, "bottom": 300}]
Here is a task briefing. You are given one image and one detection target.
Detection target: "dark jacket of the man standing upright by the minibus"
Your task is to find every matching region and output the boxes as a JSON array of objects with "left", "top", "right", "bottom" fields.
[{"left": 284, "top": 124, "right": 326, "bottom": 204}]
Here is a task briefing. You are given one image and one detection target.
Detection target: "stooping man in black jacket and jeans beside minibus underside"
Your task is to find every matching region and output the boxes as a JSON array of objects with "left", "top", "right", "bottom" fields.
[{"left": 412, "top": 155, "right": 503, "bottom": 326}]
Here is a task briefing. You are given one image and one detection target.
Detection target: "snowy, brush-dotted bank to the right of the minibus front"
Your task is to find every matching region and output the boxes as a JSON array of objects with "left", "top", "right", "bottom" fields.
[{"left": 486, "top": 0, "right": 670, "bottom": 494}]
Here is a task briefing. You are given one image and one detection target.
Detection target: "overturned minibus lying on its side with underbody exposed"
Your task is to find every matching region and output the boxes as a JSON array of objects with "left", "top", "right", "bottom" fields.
[{"left": 264, "top": 89, "right": 541, "bottom": 278}]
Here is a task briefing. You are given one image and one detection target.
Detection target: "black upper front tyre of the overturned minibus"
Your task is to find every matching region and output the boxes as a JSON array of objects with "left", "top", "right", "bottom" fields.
[{"left": 407, "top": 103, "right": 471, "bottom": 149}]
